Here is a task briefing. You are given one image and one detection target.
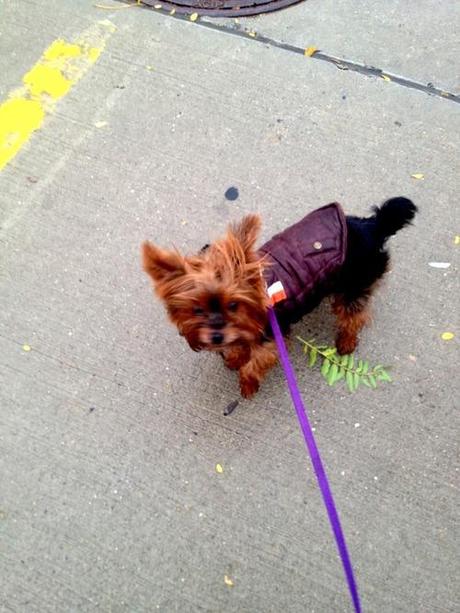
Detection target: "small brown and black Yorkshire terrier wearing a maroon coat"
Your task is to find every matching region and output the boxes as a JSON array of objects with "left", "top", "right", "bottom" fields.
[{"left": 142, "top": 197, "right": 417, "bottom": 398}]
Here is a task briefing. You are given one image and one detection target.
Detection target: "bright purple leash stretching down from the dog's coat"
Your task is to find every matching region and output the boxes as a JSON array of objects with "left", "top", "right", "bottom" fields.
[{"left": 268, "top": 308, "right": 361, "bottom": 613}]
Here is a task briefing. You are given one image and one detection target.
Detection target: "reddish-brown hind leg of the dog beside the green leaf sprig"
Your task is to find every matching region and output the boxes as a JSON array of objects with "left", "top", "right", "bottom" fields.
[{"left": 332, "top": 292, "right": 371, "bottom": 355}]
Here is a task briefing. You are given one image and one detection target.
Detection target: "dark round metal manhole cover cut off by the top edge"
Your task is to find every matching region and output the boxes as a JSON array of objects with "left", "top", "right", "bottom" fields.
[{"left": 142, "top": 0, "right": 302, "bottom": 17}]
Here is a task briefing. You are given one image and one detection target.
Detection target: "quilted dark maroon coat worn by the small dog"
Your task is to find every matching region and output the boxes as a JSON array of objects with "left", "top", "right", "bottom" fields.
[{"left": 259, "top": 202, "right": 347, "bottom": 326}]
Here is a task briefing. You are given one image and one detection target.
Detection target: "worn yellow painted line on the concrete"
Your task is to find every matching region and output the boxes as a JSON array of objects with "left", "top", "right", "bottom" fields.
[{"left": 0, "top": 19, "right": 116, "bottom": 170}]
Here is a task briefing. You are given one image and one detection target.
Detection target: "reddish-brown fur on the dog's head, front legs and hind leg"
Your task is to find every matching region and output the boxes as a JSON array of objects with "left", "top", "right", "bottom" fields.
[{"left": 143, "top": 215, "right": 358, "bottom": 398}]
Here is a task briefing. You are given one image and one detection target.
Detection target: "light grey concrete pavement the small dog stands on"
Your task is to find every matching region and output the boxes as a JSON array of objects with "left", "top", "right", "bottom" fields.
[{"left": 0, "top": 0, "right": 460, "bottom": 613}]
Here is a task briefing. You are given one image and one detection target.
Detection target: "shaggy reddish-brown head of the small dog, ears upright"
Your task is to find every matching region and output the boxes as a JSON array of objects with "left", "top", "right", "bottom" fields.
[{"left": 142, "top": 215, "right": 268, "bottom": 351}]
